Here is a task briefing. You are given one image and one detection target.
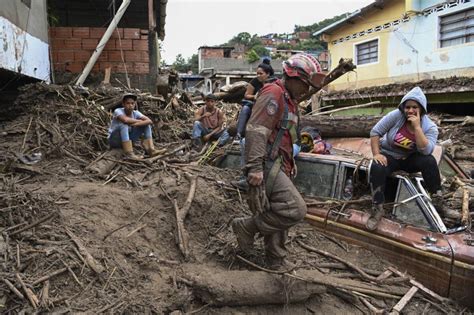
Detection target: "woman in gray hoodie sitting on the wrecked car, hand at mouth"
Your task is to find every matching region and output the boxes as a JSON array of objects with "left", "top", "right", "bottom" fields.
[{"left": 367, "top": 87, "right": 441, "bottom": 230}]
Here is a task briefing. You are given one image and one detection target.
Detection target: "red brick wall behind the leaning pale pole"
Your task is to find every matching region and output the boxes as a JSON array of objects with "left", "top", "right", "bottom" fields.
[{"left": 49, "top": 27, "right": 149, "bottom": 75}]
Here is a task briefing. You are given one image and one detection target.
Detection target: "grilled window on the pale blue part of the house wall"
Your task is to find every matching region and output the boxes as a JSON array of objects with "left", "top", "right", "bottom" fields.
[{"left": 439, "top": 8, "right": 474, "bottom": 47}]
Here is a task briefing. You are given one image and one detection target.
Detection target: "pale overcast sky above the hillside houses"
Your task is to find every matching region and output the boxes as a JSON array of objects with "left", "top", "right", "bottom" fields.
[{"left": 162, "top": 0, "right": 373, "bottom": 63}]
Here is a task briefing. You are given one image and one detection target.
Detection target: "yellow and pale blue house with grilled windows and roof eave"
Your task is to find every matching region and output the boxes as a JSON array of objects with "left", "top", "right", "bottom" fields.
[{"left": 314, "top": 0, "right": 474, "bottom": 91}]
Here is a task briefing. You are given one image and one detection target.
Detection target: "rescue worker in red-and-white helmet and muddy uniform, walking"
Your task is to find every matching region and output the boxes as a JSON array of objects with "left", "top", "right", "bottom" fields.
[{"left": 232, "top": 54, "right": 325, "bottom": 270}]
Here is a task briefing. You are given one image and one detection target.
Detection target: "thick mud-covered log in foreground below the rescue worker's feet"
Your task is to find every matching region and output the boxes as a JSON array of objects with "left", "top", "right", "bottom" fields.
[{"left": 182, "top": 265, "right": 406, "bottom": 306}]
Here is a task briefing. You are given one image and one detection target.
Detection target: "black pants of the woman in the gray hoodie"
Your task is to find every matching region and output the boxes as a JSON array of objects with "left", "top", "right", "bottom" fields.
[{"left": 370, "top": 152, "right": 441, "bottom": 204}]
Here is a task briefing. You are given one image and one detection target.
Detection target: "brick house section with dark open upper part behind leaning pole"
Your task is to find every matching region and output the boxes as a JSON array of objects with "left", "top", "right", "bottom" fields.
[{"left": 48, "top": 0, "right": 167, "bottom": 92}]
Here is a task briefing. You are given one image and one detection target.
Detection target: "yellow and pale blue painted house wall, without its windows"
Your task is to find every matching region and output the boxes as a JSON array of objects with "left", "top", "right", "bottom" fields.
[{"left": 328, "top": 0, "right": 474, "bottom": 90}]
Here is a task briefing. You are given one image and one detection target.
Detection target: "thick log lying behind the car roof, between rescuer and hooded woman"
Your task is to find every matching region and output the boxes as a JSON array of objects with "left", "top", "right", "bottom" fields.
[{"left": 300, "top": 115, "right": 382, "bottom": 138}]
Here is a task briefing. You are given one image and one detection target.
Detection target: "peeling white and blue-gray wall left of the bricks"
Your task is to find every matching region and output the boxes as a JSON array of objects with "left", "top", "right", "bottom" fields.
[{"left": 0, "top": 0, "right": 50, "bottom": 82}]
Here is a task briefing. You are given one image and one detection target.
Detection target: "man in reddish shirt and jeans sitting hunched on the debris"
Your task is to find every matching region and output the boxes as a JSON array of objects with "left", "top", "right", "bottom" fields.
[{"left": 192, "top": 94, "right": 230, "bottom": 148}]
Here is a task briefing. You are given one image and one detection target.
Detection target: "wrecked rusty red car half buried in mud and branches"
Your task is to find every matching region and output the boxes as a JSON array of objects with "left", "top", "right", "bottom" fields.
[{"left": 221, "top": 139, "right": 474, "bottom": 308}]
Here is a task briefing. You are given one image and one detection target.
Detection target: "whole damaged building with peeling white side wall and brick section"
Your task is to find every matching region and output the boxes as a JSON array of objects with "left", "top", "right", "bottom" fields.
[{"left": 0, "top": 0, "right": 167, "bottom": 105}]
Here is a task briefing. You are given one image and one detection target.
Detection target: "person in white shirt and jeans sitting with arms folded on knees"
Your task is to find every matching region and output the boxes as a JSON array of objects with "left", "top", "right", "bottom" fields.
[{"left": 108, "top": 93, "right": 166, "bottom": 160}]
